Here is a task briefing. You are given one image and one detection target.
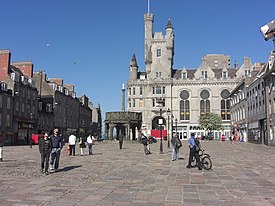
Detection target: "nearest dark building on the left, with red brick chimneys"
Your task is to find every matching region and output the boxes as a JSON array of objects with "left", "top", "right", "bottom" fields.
[{"left": 0, "top": 50, "right": 38, "bottom": 144}]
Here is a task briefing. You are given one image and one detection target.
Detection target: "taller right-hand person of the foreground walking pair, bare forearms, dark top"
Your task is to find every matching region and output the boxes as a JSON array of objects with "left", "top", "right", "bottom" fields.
[{"left": 50, "top": 129, "right": 63, "bottom": 172}]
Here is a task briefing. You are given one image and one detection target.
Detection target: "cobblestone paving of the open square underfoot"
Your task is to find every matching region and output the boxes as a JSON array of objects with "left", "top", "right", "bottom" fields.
[{"left": 0, "top": 141, "right": 275, "bottom": 206}]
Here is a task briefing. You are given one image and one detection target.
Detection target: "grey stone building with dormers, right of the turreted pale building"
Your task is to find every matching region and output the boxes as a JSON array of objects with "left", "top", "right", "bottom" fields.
[{"left": 230, "top": 63, "right": 267, "bottom": 144}]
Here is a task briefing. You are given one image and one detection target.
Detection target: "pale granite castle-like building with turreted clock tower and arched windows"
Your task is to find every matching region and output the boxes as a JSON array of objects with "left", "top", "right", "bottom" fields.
[{"left": 127, "top": 10, "right": 252, "bottom": 142}]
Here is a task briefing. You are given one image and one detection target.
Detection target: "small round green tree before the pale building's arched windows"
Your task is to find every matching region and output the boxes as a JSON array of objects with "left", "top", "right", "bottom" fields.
[{"left": 199, "top": 113, "right": 224, "bottom": 134}]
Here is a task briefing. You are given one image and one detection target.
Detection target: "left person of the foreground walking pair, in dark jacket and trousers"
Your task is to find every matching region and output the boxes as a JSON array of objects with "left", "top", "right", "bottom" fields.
[{"left": 38, "top": 132, "right": 52, "bottom": 175}]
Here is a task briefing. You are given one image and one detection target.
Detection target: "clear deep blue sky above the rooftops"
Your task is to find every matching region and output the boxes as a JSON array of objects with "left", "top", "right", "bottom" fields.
[{"left": 0, "top": 0, "right": 275, "bottom": 118}]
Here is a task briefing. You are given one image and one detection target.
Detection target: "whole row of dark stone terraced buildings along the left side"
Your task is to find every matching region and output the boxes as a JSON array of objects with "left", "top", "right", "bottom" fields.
[{"left": 0, "top": 49, "right": 101, "bottom": 146}]
